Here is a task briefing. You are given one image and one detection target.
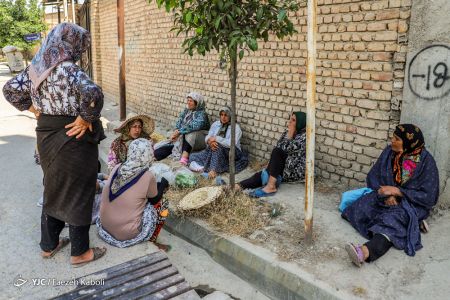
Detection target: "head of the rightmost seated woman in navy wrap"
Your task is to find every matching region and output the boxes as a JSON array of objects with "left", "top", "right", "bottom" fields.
[{"left": 391, "top": 124, "right": 425, "bottom": 153}]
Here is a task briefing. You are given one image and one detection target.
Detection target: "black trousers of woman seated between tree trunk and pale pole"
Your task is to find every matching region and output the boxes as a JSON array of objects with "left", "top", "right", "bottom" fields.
[{"left": 239, "top": 147, "right": 287, "bottom": 189}]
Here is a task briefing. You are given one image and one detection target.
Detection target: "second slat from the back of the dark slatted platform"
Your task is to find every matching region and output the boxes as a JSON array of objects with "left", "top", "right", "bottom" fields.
[{"left": 74, "top": 260, "right": 174, "bottom": 300}]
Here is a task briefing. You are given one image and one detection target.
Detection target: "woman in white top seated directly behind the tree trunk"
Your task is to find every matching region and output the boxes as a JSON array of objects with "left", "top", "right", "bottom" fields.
[{"left": 189, "top": 107, "right": 248, "bottom": 178}]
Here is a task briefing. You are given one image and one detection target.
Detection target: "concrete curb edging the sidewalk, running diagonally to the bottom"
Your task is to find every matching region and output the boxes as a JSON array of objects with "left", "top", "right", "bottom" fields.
[{"left": 165, "top": 217, "right": 343, "bottom": 300}]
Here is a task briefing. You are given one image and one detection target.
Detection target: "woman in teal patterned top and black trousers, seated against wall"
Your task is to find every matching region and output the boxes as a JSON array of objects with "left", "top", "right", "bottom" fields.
[{"left": 155, "top": 92, "right": 209, "bottom": 165}]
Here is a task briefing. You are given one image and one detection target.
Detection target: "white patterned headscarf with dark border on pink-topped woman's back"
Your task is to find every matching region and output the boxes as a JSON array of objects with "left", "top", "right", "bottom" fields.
[{"left": 109, "top": 139, "right": 154, "bottom": 201}]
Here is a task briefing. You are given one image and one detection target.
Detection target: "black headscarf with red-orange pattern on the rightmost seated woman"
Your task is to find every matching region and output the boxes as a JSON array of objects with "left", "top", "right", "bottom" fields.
[{"left": 392, "top": 124, "right": 425, "bottom": 185}]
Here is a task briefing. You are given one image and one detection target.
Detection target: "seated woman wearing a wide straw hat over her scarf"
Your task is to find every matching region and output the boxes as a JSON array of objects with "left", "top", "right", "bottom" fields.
[{"left": 108, "top": 115, "right": 155, "bottom": 172}]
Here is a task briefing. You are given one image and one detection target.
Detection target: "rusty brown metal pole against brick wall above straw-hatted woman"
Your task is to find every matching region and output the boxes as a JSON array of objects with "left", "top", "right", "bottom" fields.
[{"left": 117, "top": 0, "right": 127, "bottom": 121}]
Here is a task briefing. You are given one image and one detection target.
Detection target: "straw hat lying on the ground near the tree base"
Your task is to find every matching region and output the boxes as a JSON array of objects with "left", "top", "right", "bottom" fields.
[{"left": 178, "top": 186, "right": 223, "bottom": 210}]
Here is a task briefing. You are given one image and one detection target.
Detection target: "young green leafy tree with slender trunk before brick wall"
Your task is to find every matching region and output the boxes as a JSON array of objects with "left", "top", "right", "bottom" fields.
[{"left": 148, "top": 0, "right": 299, "bottom": 187}]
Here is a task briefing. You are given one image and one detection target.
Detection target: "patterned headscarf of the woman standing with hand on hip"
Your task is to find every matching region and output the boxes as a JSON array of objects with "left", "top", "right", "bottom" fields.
[{"left": 29, "top": 23, "right": 91, "bottom": 90}]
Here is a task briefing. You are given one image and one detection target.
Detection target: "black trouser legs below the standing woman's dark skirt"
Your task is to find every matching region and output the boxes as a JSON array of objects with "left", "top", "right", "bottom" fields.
[{"left": 39, "top": 212, "right": 91, "bottom": 256}]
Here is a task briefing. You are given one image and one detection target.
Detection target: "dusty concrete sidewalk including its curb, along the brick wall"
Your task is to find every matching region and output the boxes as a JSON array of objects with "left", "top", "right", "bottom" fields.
[{"left": 101, "top": 97, "right": 450, "bottom": 299}]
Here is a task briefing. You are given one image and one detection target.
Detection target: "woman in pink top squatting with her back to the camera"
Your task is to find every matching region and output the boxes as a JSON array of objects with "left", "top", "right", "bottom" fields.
[{"left": 97, "top": 138, "right": 168, "bottom": 248}]
